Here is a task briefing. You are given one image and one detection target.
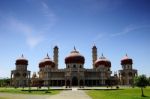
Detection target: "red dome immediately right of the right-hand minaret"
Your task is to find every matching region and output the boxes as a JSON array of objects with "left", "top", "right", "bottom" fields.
[{"left": 95, "top": 54, "right": 111, "bottom": 67}]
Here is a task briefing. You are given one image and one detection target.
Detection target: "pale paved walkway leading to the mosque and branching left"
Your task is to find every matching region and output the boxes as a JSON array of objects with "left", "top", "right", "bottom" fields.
[{"left": 0, "top": 88, "right": 91, "bottom": 99}]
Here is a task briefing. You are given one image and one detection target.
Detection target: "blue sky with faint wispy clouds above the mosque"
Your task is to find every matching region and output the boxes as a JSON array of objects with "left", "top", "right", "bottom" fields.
[{"left": 0, "top": 0, "right": 150, "bottom": 77}]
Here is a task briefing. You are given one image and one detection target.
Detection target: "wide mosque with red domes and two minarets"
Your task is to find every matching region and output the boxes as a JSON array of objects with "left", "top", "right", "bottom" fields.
[{"left": 11, "top": 45, "right": 137, "bottom": 87}]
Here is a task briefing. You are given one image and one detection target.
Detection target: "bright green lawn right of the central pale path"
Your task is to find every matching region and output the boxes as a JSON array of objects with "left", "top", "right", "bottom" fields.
[{"left": 86, "top": 87, "right": 150, "bottom": 99}]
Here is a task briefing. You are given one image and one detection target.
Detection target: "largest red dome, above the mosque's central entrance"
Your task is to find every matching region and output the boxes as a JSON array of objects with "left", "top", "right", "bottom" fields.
[{"left": 65, "top": 48, "right": 85, "bottom": 64}]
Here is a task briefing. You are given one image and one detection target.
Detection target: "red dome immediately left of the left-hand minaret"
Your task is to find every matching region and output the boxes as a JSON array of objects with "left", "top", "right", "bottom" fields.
[{"left": 39, "top": 54, "right": 55, "bottom": 67}]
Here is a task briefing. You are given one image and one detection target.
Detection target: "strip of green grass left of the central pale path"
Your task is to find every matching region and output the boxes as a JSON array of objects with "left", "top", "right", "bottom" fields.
[{"left": 0, "top": 88, "right": 60, "bottom": 94}]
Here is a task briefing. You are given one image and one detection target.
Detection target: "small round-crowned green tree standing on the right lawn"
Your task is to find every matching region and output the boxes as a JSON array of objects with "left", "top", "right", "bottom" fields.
[{"left": 134, "top": 75, "right": 148, "bottom": 97}]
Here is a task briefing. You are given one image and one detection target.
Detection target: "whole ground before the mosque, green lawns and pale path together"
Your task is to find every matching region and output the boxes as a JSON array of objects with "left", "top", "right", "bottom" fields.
[{"left": 0, "top": 87, "right": 150, "bottom": 99}]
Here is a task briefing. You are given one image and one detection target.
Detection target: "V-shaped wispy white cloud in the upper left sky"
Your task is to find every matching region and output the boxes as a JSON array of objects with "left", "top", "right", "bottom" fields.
[{"left": 0, "top": 1, "right": 56, "bottom": 48}]
